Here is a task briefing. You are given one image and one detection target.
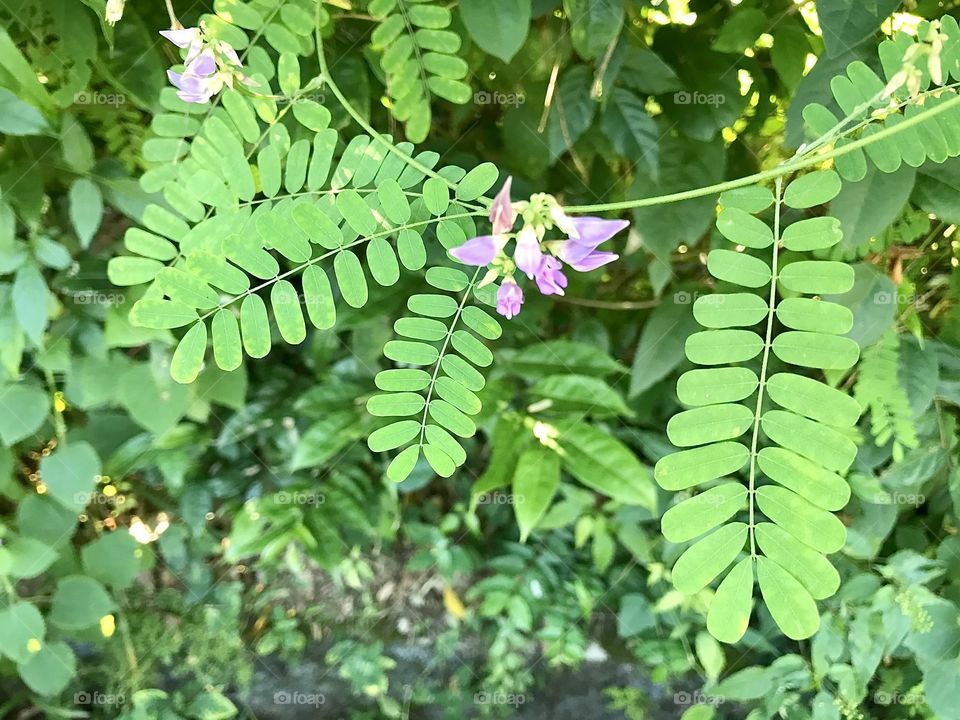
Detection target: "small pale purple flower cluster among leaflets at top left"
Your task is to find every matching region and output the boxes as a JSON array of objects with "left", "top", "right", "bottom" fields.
[{"left": 160, "top": 28, "right": 247, "bottom": 104}]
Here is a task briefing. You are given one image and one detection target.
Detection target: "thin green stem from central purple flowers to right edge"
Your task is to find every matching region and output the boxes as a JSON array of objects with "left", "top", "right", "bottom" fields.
[{"left": 564, "top": 90, "right": 960, "bottom": 213}]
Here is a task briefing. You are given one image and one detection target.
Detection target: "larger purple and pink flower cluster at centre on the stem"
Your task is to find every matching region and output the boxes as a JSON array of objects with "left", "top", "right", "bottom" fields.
[{"left": 450, "top": 178, "right": 629, "bottom": 319}]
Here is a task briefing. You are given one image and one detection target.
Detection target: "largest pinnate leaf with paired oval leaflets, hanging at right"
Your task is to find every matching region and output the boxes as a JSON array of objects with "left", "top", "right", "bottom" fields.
[{"left": 654, "top": 179, "right": 860, "bottom": 642}]
